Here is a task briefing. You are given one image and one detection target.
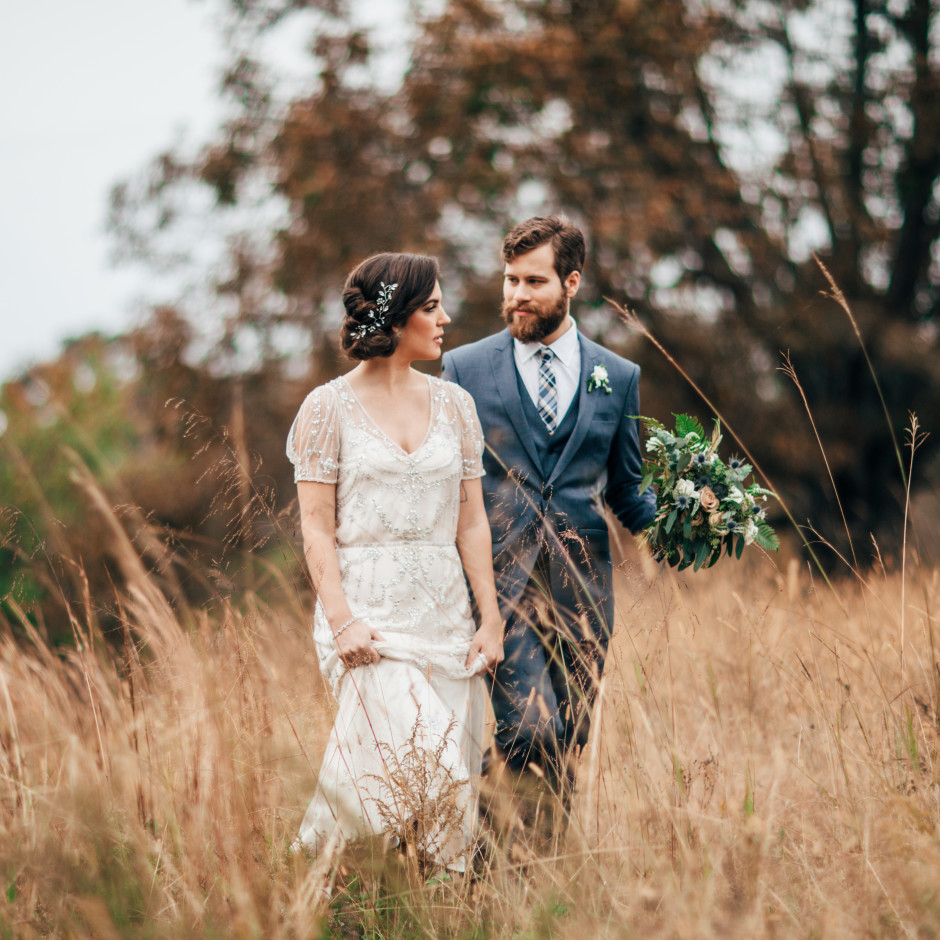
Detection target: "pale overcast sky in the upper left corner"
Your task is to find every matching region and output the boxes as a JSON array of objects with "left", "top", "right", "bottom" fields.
[{"left": 0, "top": 0, "right": 222, "bottom": 380}]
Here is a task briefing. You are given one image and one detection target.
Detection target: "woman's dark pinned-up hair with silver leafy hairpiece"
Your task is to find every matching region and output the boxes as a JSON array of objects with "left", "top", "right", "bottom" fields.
[{"left": 340, "top": 252, "right": 440, "bottom": 359}]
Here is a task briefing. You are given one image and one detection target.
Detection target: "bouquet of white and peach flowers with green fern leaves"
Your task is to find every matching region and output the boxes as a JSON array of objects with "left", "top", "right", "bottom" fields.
[{"left": 640, "top": 415, "right": 780, "bottom": 571}]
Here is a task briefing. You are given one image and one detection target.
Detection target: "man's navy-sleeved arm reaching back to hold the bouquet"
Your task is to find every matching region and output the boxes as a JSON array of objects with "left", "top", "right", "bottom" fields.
[{"left": 604, "top": 365, "right": 656, "bottom": 534}]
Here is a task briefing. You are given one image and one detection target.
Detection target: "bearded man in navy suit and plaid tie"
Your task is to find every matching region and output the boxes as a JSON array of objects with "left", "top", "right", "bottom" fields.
[{"left": 443, "top": 216, "right": 655, "bottom": 828}]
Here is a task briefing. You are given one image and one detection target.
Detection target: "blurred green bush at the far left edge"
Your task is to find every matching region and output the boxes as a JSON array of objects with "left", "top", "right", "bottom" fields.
[{"left": 0, "top": 335, "right": 152, "bottom": 641}]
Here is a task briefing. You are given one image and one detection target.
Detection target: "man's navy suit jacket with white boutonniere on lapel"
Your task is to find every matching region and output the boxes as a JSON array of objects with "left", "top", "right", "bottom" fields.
[{"left": 443, "top": 330, "right": 656, "bottom": 633}]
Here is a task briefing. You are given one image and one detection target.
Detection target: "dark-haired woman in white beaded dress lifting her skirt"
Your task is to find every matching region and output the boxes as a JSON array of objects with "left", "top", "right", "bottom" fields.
[{"left": 287, "top": 254, "right": 503, "bottom": 870}]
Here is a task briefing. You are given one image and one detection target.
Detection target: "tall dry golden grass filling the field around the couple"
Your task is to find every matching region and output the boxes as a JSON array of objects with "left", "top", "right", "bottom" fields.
[{"left": 0, "top": 466, "right": 940, "bottom": 938}]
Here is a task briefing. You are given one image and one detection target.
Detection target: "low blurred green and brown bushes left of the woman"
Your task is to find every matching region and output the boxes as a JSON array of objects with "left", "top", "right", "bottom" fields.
[{"left": 0, "top": 324, "right": 300, "bottom": 643}]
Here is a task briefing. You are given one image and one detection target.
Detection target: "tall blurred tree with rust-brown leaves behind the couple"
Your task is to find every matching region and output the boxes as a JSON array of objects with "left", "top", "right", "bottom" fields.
[{"left": 104, "top": 0, "right": 940, "bottom": 564}]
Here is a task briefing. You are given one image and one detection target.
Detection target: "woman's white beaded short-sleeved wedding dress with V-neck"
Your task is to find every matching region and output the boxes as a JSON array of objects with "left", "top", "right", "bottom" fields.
[{"left": 287, "top": 377, "right": 487, "bottom": 869}]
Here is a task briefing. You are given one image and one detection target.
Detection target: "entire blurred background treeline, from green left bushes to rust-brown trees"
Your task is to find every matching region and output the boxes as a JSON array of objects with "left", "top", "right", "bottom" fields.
[{"left": 0, "top": 0, "right": 940, "bottom": 644}]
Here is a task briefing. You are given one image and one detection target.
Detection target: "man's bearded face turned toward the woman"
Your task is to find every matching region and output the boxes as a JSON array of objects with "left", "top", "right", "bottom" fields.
[{"left": 502, "top": 243, "right": 581, "bottom": 343}]
